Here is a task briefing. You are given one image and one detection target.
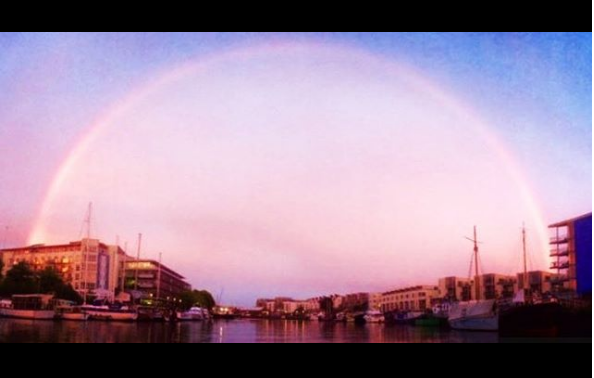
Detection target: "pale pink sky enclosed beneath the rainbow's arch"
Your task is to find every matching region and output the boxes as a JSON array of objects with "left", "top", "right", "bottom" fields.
[{"left": 16, "top": 45, "right": 547, "bottom": 304}]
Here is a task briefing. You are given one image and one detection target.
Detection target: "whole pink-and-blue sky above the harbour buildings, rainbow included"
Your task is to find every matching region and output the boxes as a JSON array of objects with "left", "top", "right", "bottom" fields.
[{"left": 0, "top": 32, "right": 592, "bottom": 305}]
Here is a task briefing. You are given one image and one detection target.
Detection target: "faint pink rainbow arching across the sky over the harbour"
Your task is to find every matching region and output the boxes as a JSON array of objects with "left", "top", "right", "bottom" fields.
[{"left": 28, "top": 42, "right": 548, "bottom": 257}]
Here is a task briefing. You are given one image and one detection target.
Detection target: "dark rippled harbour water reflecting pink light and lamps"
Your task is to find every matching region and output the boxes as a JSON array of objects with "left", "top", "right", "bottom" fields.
[{"left": 0, "top": 319, "right": 499, "bottom": 343}]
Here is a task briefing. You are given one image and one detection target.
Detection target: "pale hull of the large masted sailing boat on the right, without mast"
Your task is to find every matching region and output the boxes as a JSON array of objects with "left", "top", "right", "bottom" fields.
[{"left": 448, "top": 300, "right": 499, "bottom": 332}]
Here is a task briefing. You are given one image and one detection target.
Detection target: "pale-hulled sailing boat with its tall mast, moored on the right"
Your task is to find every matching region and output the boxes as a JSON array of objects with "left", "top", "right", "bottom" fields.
[{"left": 448, "top": 226, "right": 499, "bottom": 332}]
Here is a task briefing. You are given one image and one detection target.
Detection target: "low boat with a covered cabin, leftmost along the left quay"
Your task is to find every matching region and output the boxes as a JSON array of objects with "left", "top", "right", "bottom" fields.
[{"left": 1, "top": 294, "right": 56, "bottom": 320}]
